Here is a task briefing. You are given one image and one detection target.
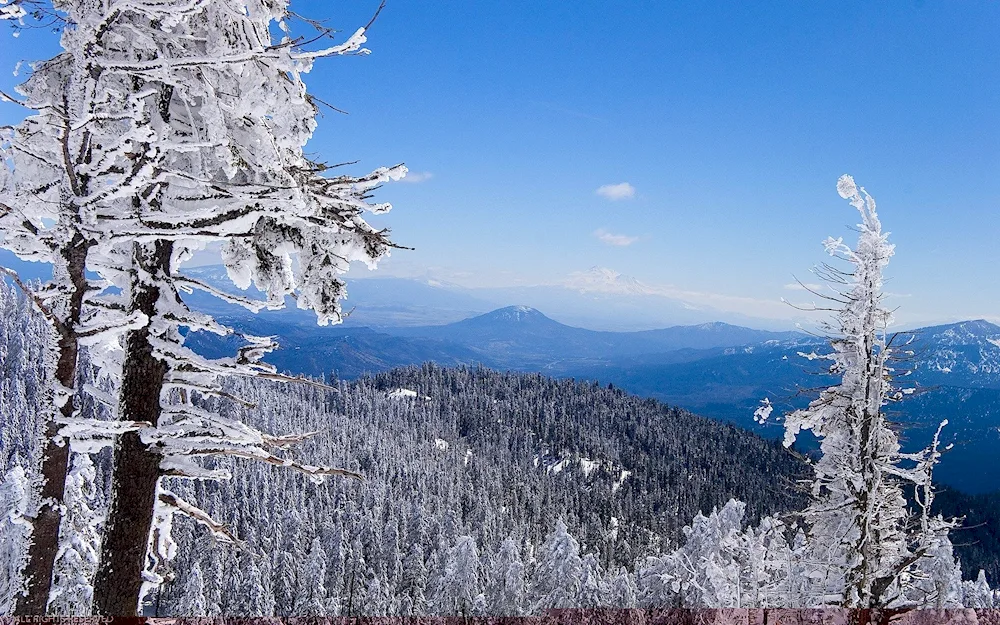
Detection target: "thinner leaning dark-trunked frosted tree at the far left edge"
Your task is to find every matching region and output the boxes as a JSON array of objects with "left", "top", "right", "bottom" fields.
[{"left": 0, "top": 102, "right": 93, "bottom": 615}]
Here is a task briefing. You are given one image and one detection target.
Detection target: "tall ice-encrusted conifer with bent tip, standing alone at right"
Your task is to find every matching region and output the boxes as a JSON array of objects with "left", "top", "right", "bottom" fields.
[{"left": 758, "top": 175, "right": 951, "bottom": 609}]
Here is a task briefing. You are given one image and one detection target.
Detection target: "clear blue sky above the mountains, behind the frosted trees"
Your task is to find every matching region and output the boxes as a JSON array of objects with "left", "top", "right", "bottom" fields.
[{"left": 0, "top": 0, "right": 1000, "bottom": 323}]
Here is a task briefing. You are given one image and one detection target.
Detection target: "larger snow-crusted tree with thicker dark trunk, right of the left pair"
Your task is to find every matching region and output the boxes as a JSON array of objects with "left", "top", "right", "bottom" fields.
[{"left": 86, "top": 0, "right": 405, "bottom": 614}]
